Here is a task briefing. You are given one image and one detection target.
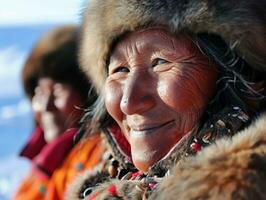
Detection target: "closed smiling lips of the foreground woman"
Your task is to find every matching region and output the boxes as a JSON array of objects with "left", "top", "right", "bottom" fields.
[{"left": 130, "top": 120, "right": 174, "bottom": 136}]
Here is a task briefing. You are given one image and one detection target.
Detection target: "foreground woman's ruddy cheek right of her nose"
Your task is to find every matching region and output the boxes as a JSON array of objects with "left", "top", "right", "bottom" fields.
[{"left": 158, "top": 65, "right": 217, "bottom": 113}]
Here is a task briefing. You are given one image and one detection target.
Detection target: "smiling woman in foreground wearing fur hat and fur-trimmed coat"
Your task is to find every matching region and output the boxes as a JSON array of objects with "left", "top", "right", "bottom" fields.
[{"left": 68, "top": 0, "right": 266, "bottom": 199}]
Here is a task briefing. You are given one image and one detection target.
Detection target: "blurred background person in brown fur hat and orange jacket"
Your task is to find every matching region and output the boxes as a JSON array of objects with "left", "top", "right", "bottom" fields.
[{"left": 13, "top": 25, "right": 104, "bottom": 200}]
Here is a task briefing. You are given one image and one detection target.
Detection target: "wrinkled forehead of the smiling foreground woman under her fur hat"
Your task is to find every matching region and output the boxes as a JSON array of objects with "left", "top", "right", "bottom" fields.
[{"left": 111, "top": 27, "right": 197, "bottom": 59}]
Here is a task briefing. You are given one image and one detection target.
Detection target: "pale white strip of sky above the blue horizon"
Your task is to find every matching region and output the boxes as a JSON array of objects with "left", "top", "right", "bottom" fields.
[{"left": 0, "top": 0, "right": 84, "bottom": 26}]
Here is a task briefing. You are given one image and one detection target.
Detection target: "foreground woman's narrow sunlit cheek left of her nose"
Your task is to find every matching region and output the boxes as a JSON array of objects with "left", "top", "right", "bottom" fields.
[{"left": 104, "top": 83, "right": 123, "bottom": 124}]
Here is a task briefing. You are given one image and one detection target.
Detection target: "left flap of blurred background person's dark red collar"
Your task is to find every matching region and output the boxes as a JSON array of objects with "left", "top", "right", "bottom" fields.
[{"left": 19, "top": 126, "right": 47, "bottom": 160}]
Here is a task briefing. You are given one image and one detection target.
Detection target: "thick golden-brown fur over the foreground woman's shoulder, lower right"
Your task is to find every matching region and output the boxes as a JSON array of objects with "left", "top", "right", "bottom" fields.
[{"left": 150, "top": 115, "right": 266, "bottom": 200}]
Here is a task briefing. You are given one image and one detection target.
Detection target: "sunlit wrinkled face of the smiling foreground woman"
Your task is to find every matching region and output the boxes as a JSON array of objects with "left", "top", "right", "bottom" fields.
[{"left": 105, "top": 28, "right": 218, "bottom": 171}]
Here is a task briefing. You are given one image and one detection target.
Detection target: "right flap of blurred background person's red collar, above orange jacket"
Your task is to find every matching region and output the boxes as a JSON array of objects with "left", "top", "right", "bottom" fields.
[{"left": 33, "top": 128, "right": 78, "bottom": 176}]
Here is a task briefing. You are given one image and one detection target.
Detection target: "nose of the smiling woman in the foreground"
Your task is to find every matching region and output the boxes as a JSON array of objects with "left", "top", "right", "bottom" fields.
[{"left": 120, "top": 74, "right": 156, "bottom": 115}]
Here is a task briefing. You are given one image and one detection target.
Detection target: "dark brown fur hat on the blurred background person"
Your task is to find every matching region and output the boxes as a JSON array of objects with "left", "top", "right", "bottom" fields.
[{"left": 21, "top": 24, "right": 91, "bottom": 100}]
